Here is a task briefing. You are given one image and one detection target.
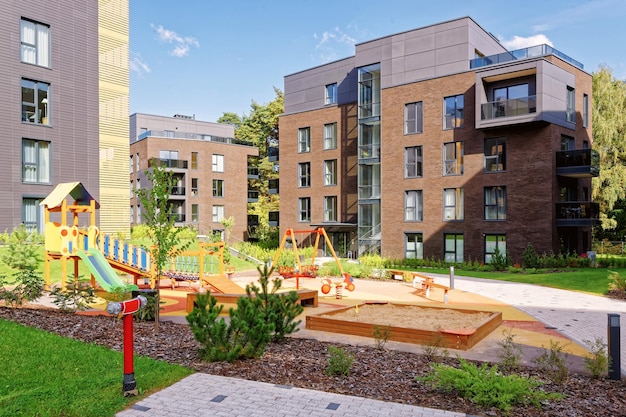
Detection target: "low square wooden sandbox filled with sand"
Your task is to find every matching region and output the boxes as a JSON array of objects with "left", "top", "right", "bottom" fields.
[{"left": 306, "top": 303, "right": 502, "bottom": 350}]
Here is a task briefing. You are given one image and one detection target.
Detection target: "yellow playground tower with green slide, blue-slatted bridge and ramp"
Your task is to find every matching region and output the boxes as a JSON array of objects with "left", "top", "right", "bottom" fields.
[{"left": 40, "top": 182, "right": 233, "bottom": 293}]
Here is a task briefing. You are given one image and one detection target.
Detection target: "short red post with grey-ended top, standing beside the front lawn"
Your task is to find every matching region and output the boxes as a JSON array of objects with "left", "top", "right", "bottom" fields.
[{"left": 107, "top": 295, "right": 148, "bottom": 397}]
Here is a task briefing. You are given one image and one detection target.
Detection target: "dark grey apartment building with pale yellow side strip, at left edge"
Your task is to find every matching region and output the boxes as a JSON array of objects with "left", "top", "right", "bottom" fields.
[{"left": 0, "top": 0, "right": 129, "bottom": 232}]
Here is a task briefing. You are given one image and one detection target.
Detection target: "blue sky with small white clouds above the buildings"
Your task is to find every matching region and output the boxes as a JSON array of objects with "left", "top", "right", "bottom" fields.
[{"left": 130, "top": 0, "right": 626, "bottom": 121}]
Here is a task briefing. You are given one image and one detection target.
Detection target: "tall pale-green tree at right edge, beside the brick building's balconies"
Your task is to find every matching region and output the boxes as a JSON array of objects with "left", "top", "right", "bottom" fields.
[{"left": 593, "top": 67, "right": 626, "bottom": 230}]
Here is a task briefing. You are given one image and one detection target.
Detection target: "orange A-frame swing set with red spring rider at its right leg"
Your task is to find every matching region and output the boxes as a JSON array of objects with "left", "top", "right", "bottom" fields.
[{"left": 272, "top": 227, "right": 354, "bottom": 294}]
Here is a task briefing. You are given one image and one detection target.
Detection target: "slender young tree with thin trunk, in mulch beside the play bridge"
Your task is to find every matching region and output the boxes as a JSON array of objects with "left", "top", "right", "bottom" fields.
[{"left": 137, "top": 166, "right": 189, "bottom": 332}]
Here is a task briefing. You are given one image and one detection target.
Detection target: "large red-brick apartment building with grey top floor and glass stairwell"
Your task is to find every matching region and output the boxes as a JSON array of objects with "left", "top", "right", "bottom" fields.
[{"left": 279, "top": 17, "right": 599, "bottom": 262}]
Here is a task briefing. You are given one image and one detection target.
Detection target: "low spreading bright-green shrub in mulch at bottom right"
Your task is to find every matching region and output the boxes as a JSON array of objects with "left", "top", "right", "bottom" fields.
[{"left": 416, "top": 359, "right": 562, "bottom": 414}]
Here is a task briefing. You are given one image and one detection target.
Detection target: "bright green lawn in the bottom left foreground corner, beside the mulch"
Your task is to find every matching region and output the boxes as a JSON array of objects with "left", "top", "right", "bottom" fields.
[{"left": 0, "top": 320, "right": 192, "bottom": 417}]
